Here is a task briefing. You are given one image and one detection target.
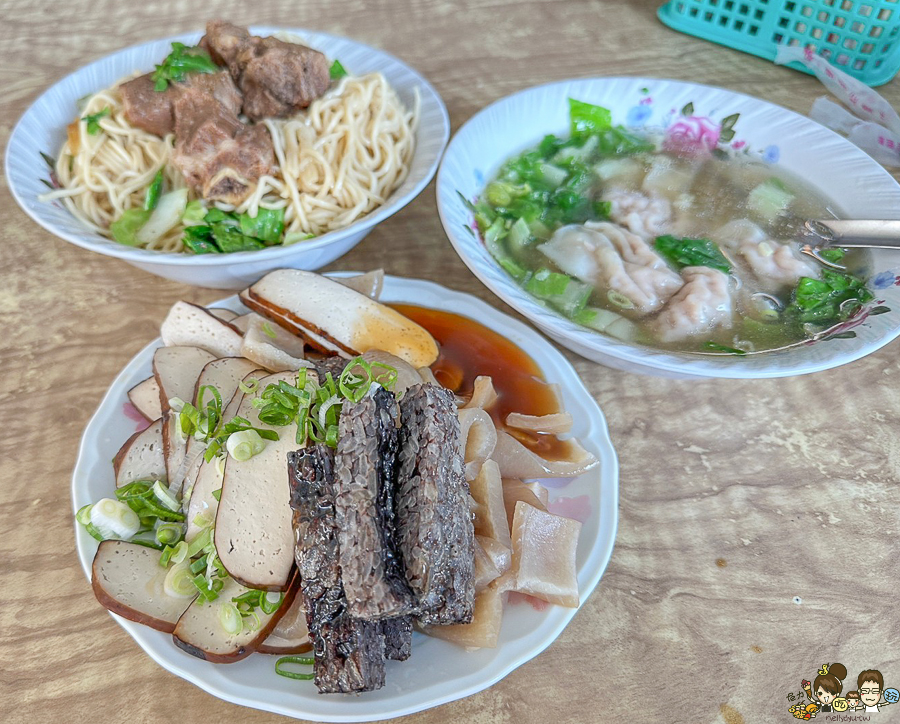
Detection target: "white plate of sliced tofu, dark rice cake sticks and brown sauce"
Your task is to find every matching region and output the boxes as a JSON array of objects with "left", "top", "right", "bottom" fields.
[{"left": 72, "top": 270, "right": 618, "bottom": 722}]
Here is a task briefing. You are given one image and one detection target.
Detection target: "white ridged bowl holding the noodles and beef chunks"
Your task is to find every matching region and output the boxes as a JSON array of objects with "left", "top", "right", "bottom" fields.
[{"left": 6, "top": 27, "right": 450, "bottom": 289}]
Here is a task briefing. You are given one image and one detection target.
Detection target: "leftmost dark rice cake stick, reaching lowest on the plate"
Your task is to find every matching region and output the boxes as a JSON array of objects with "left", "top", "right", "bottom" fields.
[{"left": 288, "top": 445, "right": 385, "bottom": 693}]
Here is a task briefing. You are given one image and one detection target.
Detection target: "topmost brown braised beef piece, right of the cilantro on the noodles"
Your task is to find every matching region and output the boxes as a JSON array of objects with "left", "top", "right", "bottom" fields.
[{"left": 200, "top": 20, "right": 331, "bottom": 120}]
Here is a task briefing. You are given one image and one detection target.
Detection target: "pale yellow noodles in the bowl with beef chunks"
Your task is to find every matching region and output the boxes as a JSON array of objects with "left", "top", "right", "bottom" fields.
[{"left": 41, "top": 73, "right": 419, "bottom": 252}]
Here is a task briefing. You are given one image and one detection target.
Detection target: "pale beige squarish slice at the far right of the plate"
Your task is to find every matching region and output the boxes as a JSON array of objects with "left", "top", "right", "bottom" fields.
[{"left": 512, "top": 501, "right": 581, "bottom": 608}]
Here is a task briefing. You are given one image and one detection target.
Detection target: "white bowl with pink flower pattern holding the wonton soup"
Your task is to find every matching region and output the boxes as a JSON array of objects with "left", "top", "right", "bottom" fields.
[{"left": 437, "top": 78, "right": 900, "bottom": 378}]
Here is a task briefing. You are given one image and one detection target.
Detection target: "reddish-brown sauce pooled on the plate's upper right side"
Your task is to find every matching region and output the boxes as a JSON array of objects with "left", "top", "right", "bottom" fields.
[{"left": 391, "top": 304, "right": 570, "bottom": 460}]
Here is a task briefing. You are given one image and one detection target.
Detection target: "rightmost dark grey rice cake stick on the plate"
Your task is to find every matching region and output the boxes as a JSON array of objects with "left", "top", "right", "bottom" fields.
[{"left": 395, "top": 384, "right": 475, "bottom": 624}]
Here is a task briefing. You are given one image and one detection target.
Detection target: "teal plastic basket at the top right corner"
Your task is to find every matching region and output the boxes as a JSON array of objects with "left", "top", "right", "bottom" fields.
[{"left": 659, "top": 0, "right": 900, "bottom": 85}]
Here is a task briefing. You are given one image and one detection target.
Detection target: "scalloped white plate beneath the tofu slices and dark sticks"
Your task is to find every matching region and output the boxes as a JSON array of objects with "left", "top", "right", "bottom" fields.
[{"left": 72, "top": 277, "right": 618, "bottom": 722}]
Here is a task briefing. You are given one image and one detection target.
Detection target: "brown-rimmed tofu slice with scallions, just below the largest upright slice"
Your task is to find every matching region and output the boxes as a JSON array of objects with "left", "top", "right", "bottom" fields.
[{"left": 172, "top": 576, "right": 292, "bottom": 664}]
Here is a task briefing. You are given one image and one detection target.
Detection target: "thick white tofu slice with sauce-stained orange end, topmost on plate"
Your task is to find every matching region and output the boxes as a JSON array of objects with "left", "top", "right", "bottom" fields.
[{"left": 241, "top": 269, "right": 438, "bottom": 368}]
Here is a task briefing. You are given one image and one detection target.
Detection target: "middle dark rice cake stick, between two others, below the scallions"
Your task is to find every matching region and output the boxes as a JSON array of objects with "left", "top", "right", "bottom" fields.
[{"left": 334, "top": 386, "right": 413, "bottom": 621}]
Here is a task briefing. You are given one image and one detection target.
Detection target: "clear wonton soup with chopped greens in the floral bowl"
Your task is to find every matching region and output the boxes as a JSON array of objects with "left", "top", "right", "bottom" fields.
[{"left": 473, "top": 102, "right": 872, "bottom": 355}]
